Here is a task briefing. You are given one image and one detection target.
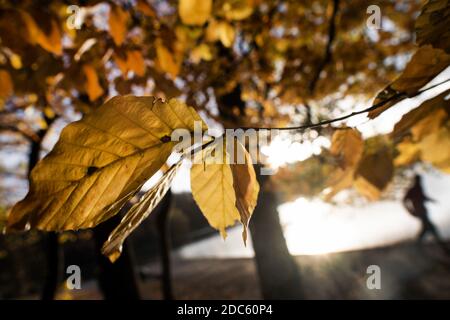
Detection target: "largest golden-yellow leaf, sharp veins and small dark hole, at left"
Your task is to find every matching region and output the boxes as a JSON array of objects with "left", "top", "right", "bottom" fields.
[{"left": 8, "top": 96, "right": 204, "bottom": 231}]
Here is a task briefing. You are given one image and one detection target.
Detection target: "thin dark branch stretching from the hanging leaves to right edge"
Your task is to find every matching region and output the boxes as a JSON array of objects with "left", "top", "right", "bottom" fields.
[{"left": 240, "top": 78, "right": 450, "bottom": 131}]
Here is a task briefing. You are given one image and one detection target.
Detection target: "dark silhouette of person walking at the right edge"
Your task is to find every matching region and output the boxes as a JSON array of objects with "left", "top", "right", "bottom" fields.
[{"left": 403, "top": 174, "right": 450, "bottom": 254}]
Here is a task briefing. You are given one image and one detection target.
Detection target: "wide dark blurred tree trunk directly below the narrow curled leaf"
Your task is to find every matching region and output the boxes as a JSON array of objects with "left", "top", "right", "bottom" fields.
[{"left": 93, "top": 214, "right": 140, "bottom": 300}]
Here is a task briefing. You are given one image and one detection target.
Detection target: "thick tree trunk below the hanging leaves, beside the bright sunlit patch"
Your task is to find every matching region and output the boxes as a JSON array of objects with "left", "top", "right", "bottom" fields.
[{"left": 250, "top": 171, "right": 303, "bottom": 299}]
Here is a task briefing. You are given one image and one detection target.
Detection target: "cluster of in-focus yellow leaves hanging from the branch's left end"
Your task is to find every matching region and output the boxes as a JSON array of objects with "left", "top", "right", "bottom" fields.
[{"left": 7, "top": 96, "right": 259, "bottom": 260}]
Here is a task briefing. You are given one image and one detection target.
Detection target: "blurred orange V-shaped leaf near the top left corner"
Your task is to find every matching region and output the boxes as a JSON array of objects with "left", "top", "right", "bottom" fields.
[{"left": 20, "top": 11, "right": 62, "bottom": 56}]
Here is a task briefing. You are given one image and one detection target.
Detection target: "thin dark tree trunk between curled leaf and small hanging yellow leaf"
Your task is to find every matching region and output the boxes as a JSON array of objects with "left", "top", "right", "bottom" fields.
[{"left": 156, "top": 190, "right": 174, "bottom": 300}]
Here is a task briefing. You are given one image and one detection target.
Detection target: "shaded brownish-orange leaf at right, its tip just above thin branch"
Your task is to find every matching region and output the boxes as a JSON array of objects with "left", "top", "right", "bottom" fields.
[{"left": 368, "top": 45, "right": 450, "bottom": 119}]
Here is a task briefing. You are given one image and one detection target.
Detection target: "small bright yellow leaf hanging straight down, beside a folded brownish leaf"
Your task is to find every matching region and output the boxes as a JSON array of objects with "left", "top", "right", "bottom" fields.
[{"left": 191, "top": 141, "right": 241, "bottom": 238}]
